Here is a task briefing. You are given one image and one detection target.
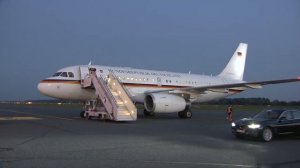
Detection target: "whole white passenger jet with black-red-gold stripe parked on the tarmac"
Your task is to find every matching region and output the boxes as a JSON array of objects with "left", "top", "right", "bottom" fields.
[{"left": 37, "top": 43, "right": 300, "bottom": 118}]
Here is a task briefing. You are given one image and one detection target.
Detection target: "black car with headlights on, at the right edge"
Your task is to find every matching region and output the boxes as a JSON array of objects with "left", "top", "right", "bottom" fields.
[{"left": 231, "top": 109, "right": 300, "bottom": 142}]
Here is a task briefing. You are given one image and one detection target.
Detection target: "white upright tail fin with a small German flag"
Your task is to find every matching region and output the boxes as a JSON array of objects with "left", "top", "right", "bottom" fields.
[{"left": 218, "top": 43, "right": 248, "bottom": 81}]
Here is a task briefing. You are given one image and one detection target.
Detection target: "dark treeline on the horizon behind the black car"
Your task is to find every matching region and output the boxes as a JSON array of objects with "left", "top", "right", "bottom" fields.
[{"left": 208, "top": 98, "right": 300, "bottom": 106}]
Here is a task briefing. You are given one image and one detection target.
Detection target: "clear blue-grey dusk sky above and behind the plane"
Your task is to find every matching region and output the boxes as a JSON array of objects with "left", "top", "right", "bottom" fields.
[{"left": 0, "top": 0, "right": 300, "bottom": 101}]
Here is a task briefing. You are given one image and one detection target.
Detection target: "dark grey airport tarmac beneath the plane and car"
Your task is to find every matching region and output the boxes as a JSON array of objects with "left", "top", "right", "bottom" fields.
[{"left": 0, "top": 104, "right": 300, "bottom": 168}]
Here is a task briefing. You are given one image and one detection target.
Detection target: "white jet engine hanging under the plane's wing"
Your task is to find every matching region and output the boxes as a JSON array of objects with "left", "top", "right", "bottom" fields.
[{"left": 144, "top": 93, "right": 187, "bottom": 113}]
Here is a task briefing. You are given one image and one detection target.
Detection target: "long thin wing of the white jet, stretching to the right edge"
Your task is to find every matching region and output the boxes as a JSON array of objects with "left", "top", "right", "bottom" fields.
[{"left": 151, "top": 77, "right": 300, "bottom": 93}]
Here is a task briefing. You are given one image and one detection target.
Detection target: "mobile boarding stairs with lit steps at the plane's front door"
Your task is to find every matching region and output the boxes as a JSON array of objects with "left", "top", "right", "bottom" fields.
[{"left": 82, "top": 68, "right": 137, "bottom": 121}]
